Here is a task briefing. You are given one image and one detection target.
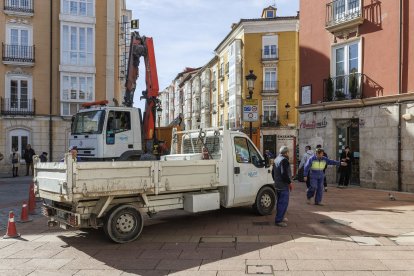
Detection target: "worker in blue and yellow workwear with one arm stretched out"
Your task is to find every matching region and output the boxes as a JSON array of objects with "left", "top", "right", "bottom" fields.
[{"left": 304, "top": 148, "right": 346, "bottom": 205}]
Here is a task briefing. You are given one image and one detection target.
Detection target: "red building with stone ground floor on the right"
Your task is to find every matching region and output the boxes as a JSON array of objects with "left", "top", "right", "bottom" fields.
[{"left": 298, "top": 0, "right": 414, "bottom": 192}]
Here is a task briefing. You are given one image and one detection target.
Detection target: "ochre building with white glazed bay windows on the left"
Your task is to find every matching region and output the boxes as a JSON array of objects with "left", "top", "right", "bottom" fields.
[{"left": 0, "top": 0, "right": 131, "bottom": 171}]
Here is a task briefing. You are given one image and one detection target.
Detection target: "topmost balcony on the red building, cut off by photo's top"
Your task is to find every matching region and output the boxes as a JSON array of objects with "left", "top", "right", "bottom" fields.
[{"left": 325, "top": 0, "right": 364, "bottom": 33}]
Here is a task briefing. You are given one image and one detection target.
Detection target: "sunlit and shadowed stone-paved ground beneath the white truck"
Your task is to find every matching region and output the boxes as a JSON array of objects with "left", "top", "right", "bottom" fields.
[{"left": 0, "top": 183, "right": 414, "bottom": 276}]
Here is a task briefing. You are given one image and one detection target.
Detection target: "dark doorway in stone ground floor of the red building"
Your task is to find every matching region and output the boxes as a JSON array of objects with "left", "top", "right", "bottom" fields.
[{"left": 331, "top": 119, "right": 360, "bottom": 185}]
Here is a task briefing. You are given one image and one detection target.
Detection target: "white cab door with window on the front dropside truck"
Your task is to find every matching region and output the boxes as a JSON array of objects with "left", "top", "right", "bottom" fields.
[{"left": 232, "top": 135, "right": 267, "bottom": 204}]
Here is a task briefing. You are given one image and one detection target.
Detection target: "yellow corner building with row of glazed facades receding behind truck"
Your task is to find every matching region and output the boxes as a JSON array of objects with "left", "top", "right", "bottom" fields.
[{"left": 160, "top": 6, "right": 299, "bottom": 157}]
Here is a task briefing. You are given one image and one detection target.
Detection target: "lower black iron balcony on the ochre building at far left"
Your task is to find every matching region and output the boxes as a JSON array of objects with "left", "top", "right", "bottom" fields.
[{"left": 0, "top": 98, "right": 36, "bottom": 116}]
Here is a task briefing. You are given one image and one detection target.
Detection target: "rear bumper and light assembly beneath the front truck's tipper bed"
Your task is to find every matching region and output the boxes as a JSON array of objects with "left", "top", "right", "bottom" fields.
[{"left": 42, "top": 204, "right": 81, "bottom": 229}]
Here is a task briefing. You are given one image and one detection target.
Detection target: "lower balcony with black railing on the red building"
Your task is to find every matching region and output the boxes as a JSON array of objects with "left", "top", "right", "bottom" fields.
[{"left": 323, "top": 73, "right": 365, "bottom": 102}]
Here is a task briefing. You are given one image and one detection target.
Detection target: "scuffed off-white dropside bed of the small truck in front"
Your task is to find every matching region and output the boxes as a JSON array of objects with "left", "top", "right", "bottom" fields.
[{"left": 34, "top": 156, "right": 222, "bottom": 202}]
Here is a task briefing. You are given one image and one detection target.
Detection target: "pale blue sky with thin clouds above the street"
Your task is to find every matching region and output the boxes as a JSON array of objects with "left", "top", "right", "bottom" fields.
[{"left": 126, "top": 0, "right": 299, "bottom": 108}]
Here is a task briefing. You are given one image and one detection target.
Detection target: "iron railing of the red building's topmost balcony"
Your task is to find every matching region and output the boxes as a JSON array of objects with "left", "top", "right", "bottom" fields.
[{"left": 325, "top": 0, "right": 363, "bottom": 28}]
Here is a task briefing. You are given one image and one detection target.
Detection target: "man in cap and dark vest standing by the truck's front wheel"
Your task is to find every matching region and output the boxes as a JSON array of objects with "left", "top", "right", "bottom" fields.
[{"left": 272, "top": 146, "right": 293, "bottom": 227}]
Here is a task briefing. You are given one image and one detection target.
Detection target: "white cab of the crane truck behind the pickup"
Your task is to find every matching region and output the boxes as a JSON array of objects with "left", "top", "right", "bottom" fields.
[{"left": 69, "top": 105, "right": 143, "bottom": 161}]
